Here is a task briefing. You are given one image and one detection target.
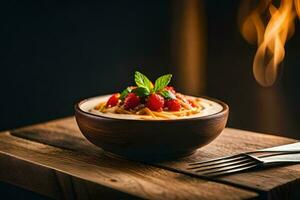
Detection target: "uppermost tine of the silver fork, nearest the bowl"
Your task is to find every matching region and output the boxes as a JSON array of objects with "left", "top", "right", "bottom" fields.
[{"left": 188, "top": 157, "right": 253, "bottom": 171}]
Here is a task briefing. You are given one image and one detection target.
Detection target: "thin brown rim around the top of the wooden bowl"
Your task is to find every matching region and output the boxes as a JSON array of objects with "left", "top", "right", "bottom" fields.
[{"left": 74, "top": 94, "right": 229, "bottom": 123}]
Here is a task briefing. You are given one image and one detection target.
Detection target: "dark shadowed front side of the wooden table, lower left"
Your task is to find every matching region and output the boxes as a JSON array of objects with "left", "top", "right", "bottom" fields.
[{"left": 0, "top": 144, "right": 136, "bottom": 199}]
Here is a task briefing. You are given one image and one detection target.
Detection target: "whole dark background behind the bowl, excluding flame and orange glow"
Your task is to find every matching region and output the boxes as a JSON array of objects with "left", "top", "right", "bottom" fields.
[{"left": 0, "top": 0, "right": 300, "bottom": 198}]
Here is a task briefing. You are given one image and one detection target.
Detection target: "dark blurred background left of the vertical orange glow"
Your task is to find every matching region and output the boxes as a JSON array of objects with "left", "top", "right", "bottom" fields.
[{"left": 0, "top": 1, "right": 171, "bottom": 129}]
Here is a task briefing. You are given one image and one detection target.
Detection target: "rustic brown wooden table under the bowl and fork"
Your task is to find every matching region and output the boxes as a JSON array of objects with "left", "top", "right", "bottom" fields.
[{"left": 0, "top": 117, "right": 300, "bottom": 199}]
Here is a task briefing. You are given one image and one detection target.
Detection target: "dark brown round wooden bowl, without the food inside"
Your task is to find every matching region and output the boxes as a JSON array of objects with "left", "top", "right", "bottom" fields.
[{"left": 75, "top": 95, "right": 229, "bottom": 160}]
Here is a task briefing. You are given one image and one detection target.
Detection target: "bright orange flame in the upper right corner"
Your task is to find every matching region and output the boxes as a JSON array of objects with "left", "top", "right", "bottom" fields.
[{"left": 240, "top": 0, "right": 300, "bottom": 87}]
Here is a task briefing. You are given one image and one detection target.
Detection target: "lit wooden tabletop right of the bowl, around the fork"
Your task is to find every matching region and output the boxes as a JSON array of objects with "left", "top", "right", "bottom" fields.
[{"left": 158, "top": 128, "right": 300, "bottom": 199}]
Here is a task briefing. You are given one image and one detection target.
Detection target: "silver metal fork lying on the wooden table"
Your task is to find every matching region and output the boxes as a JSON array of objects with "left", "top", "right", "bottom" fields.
[{"left": 187, "top": 150, "right": 300, "bottom": 176}]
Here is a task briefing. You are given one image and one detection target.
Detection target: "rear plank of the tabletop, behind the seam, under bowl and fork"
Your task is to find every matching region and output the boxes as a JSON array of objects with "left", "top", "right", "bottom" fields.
[{"left": 4, "top": 118, "right": 300, "bottom": 199}]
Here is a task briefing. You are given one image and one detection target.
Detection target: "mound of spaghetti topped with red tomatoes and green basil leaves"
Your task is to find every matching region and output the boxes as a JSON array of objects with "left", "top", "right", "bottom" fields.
[{"left": 93, "top": 72, "right": 209, "bottom": 119}]
